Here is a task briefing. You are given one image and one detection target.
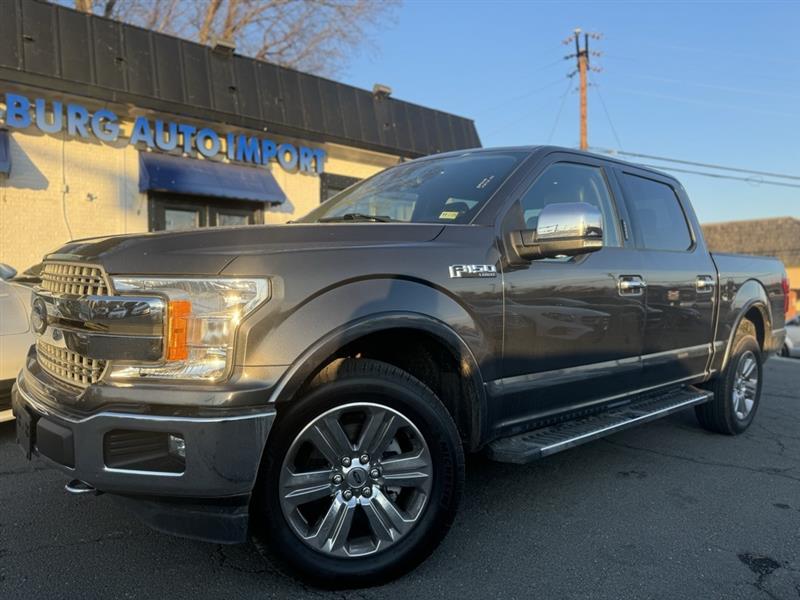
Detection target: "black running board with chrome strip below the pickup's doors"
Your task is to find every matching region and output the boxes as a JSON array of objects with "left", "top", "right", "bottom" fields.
[{"left": 488, "top": 386, "right": 713, "bottom": 464}]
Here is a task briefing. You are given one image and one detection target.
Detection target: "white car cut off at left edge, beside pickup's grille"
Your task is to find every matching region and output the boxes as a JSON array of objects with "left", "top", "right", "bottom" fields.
[{"left": 0, "top": 263, "right": 33, "bottom": 423}]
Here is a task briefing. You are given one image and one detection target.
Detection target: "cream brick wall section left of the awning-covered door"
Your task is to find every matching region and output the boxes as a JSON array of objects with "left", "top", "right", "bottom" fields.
[{"left": 0, "top": 131, "right": 147, "bottom": 269}]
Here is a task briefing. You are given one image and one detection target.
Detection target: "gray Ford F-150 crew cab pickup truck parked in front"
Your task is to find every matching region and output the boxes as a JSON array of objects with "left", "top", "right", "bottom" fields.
[{"left": 13, "top": 147, "right": 788, "bottom": 586}]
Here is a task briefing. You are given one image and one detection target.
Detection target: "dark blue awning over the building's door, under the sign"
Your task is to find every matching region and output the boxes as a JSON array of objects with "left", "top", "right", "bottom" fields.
[{"left": 139, "top": 152, "right": 286, "bottom": 204}]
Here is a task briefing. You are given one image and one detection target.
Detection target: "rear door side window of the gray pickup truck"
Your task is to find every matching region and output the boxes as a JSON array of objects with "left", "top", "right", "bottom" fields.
[{"left": 624, "top": 173, "right": 692, "bottom": 250}]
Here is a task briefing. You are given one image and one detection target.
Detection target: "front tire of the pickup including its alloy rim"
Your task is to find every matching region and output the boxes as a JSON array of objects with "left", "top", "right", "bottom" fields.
[{"left": 251, "top": 359, "right": 464, "bottom": 588}]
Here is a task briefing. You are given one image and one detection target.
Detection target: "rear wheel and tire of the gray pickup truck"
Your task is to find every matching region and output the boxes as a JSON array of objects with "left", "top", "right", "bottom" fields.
[{"left": 695, "top": 320, "right": 764, "bottom": 435}]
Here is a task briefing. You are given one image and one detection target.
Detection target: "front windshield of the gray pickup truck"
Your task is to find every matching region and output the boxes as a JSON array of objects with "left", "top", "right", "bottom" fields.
[{"left": 299, "top": 152, "right": 527, "bottom": 223}]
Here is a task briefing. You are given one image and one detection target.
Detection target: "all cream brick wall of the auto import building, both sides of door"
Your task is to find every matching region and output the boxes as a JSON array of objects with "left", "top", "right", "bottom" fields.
[{"left": 0, "top": 130, "right": 398, "bottom": 270}]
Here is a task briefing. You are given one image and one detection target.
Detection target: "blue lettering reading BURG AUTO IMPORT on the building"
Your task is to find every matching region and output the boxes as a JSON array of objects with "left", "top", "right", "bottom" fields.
[{"left": 0, "top": 93, "right": 325, "bottom": 173}]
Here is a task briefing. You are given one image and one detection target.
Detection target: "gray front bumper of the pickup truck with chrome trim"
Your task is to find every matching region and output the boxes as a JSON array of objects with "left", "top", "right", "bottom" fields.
[{"left": 12, "top": 368, "right": 275, "bottom": 499}]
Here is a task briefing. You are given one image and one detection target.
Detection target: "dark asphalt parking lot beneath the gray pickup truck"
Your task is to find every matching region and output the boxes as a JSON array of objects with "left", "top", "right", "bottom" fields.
[{"left": 0, "top": 359, "right": 800, "bottom": 599}]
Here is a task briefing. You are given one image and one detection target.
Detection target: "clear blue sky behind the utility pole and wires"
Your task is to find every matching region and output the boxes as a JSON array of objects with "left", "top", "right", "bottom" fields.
[{"left": 338, "top": 0, "right": 800, "bottom": 222}]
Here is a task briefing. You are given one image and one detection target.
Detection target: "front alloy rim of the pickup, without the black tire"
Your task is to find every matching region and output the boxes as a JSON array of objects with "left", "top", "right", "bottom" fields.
[{"left": 279, "top": 402, "right": 433, "bottom": 557}]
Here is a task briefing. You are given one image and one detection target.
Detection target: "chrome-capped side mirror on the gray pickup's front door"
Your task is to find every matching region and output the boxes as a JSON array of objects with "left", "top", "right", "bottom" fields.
[{"left": 513, "top": 202, "right": 603, "bottom": 260}]
